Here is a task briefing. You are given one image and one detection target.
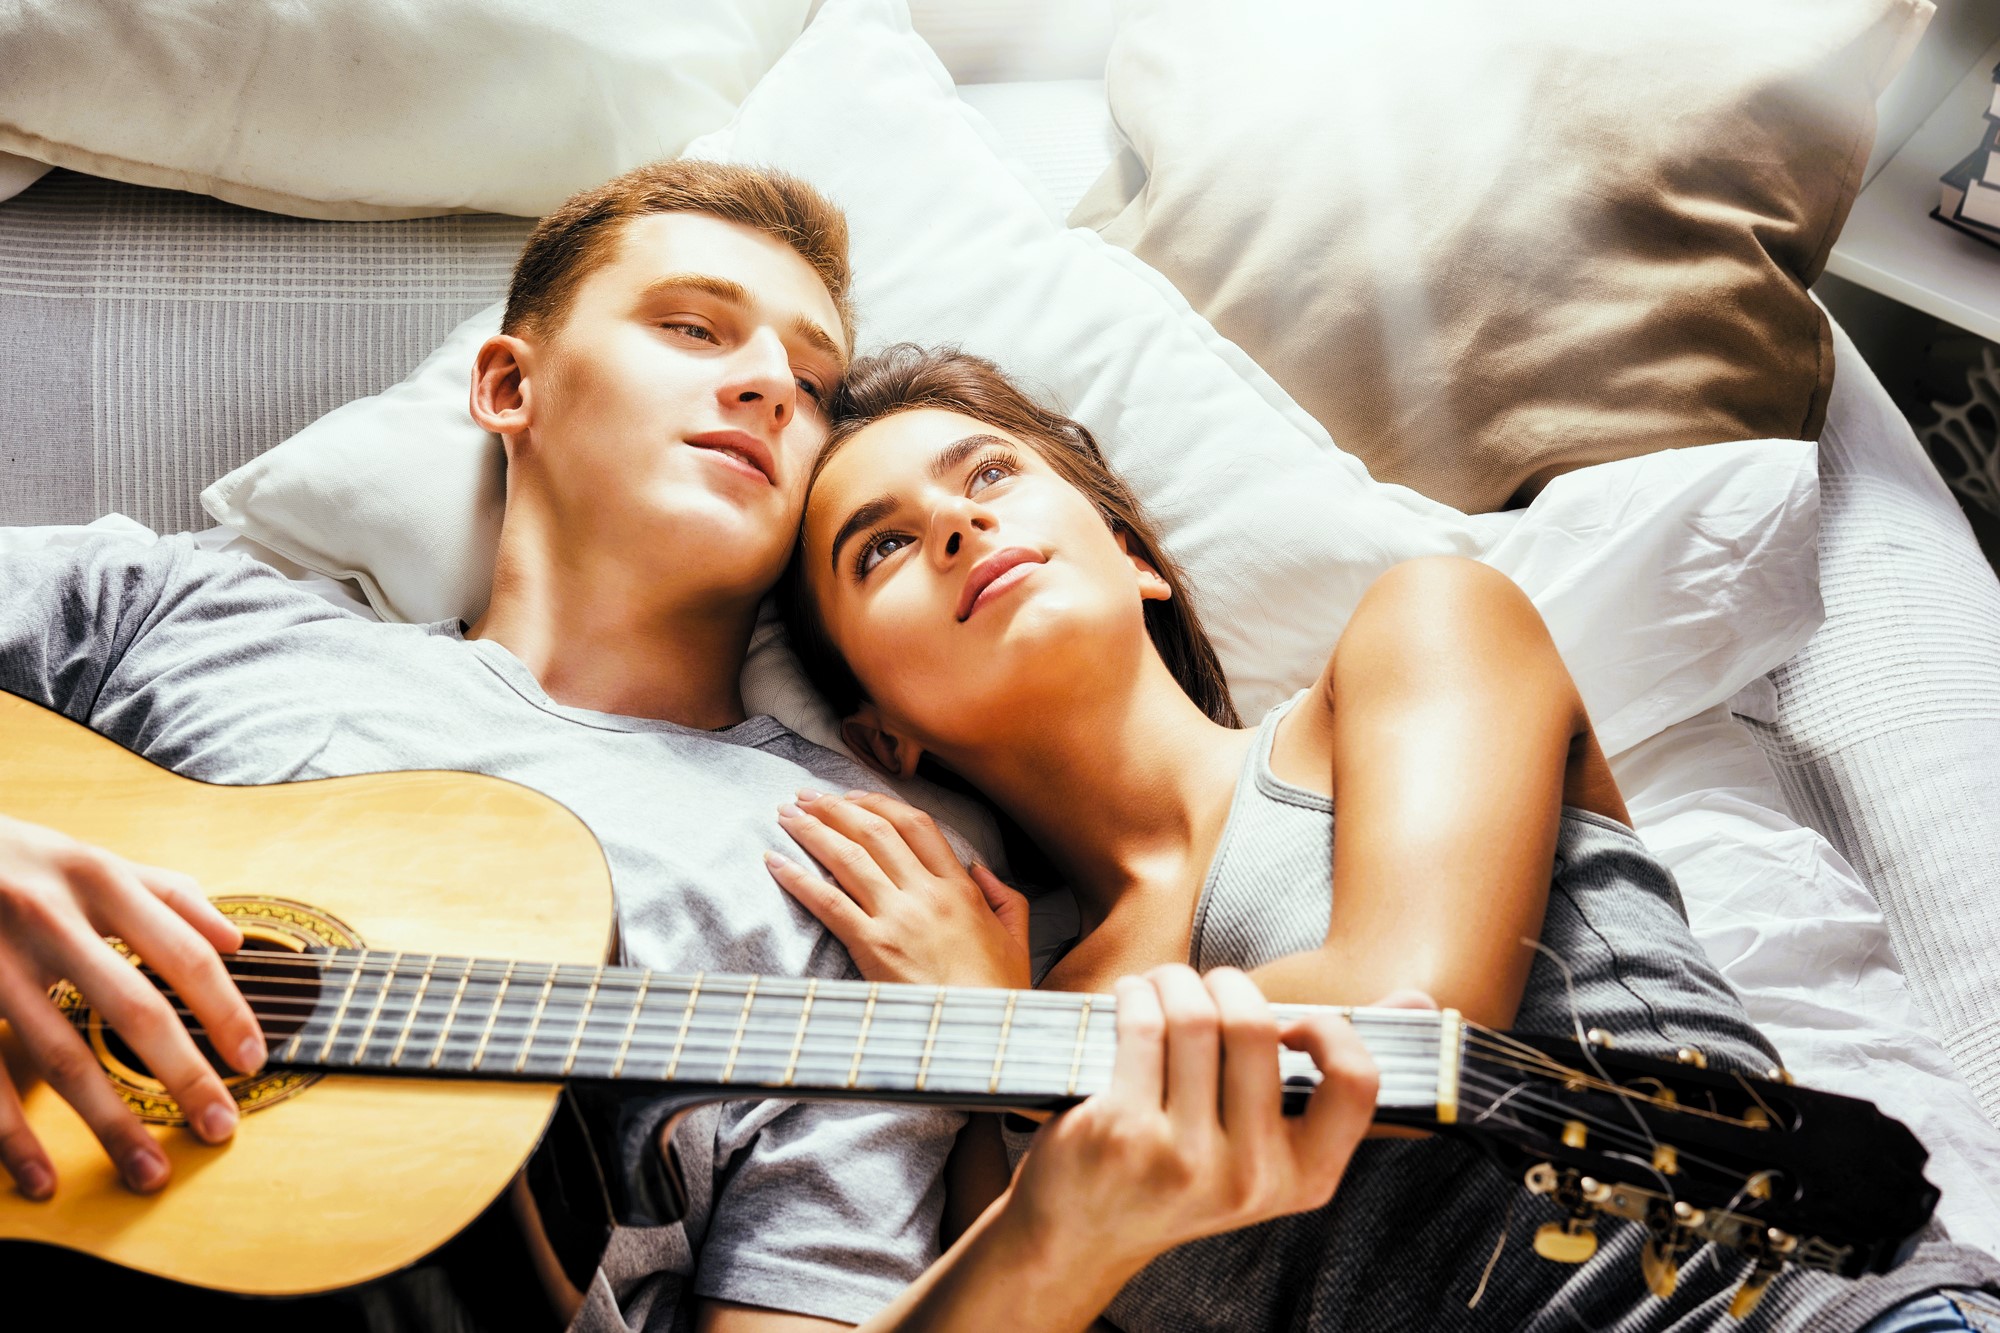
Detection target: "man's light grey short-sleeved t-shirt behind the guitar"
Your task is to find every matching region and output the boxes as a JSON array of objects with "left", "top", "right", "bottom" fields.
[{"left": 0, "top": 538, "right": 960, "bottom": 1329}]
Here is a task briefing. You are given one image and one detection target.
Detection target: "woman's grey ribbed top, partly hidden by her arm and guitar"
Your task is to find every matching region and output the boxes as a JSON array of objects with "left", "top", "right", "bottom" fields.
[{"left": 1004, "top": 697, "right": 2000, "bottom": 1333}]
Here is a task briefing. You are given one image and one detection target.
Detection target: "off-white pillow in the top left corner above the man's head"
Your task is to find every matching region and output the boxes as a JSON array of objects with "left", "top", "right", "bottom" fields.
[{"left": 0, "top": 0, "right": 808, "bottom": 218}]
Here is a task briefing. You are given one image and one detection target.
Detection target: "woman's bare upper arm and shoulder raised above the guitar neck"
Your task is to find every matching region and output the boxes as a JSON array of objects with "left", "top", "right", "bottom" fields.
[{"left": 1252, "top": 558, "right": 1626, "bottom": 1027}]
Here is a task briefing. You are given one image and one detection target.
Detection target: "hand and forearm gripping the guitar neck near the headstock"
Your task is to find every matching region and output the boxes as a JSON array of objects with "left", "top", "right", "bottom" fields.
[{"left": 862, "top": 965, "right": 1378, "bottom": 1333}]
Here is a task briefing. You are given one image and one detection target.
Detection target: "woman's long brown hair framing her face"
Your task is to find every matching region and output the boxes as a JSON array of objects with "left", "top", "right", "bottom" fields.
[{"left": 778, "top": 342, "right": 1242, "bottom": 727}]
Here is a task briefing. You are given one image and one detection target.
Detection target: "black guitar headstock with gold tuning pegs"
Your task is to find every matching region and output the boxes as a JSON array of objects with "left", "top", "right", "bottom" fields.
[{"left": 1456, "top": 1027, "right": 1938, "bottom": 1313}]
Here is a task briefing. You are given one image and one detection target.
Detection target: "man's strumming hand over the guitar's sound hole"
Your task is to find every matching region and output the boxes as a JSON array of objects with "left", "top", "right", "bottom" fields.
[{"left": 0, "top": 815, "right": 264, "bottom": 1199}]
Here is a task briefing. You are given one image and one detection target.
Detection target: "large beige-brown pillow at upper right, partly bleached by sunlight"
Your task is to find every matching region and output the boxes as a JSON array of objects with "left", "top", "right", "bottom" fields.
[{"left": 1072, "top": 0, "right": 1932, "bottom": 510}]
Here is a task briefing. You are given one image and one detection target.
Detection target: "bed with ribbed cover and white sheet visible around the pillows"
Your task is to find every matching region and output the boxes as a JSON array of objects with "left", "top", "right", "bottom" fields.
[{"left": 0, "top": 2, "right": 2000, "bottom": 1249}]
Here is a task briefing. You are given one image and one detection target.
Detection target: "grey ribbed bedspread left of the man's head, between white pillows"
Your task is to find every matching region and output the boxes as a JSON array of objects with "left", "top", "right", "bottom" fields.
[{"left": 0, "top": 170, "right": 532, "bottom": 532}]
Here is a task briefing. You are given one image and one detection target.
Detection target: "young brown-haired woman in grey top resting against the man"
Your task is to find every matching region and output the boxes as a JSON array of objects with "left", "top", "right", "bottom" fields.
[{"left": 772, "top": 346, "right": 2000, "bottom": 1331}]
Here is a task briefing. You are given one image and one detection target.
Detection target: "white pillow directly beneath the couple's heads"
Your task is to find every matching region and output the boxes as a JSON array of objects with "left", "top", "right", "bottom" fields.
[{"left": 202, "top": 0, "right": 1820, "bottom": 753}]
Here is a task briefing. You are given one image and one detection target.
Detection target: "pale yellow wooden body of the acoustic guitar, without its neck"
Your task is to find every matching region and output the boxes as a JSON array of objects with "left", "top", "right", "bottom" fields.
[{"left": 0, "top": 695, "right": 614, "bottom": 1295}]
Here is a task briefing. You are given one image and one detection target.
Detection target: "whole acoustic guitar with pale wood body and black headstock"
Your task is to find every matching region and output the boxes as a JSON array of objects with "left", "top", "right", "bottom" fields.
[{"left": 0, "top": 695, "right": 1938, "bottom": 1313}]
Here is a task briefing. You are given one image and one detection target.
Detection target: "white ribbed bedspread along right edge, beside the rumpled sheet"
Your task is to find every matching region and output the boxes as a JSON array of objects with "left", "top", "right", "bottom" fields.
[{"left": 1750, "top": 314, "right": 2000, "bottom": 1125}]
